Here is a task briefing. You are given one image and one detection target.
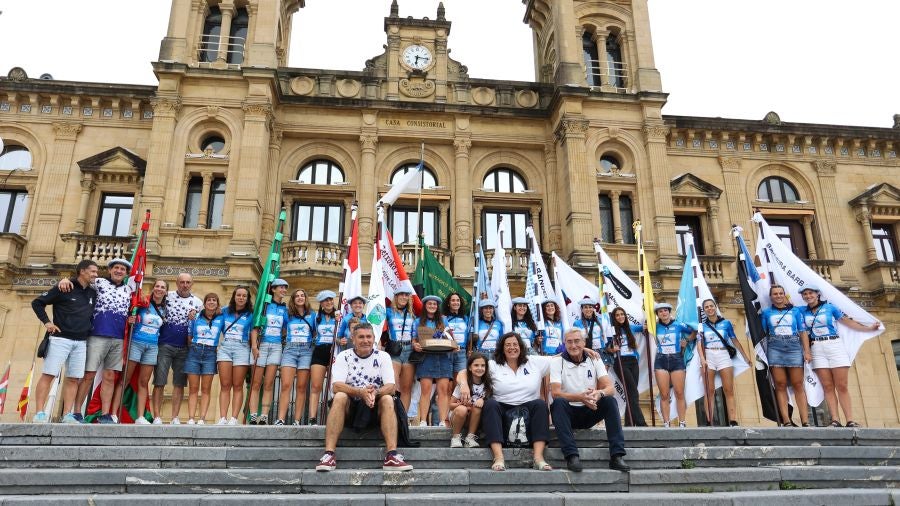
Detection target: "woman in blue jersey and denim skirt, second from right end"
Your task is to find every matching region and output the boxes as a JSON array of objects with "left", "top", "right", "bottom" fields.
[{"left": 760, "top": 285, "right": 812, "bottom": 427}]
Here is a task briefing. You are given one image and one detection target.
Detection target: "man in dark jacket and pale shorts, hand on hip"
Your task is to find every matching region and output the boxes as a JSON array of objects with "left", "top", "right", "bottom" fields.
[{"left": 31, "top": 260, "right": 97, "bottom": 423}]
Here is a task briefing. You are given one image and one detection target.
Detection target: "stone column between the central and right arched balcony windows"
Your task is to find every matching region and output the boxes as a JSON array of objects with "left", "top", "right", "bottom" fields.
[{"left": 451, "top": 137, "right": 480, "bottom": 276}]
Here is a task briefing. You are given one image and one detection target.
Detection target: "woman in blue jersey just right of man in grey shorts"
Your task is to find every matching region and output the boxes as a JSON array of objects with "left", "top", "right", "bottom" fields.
[{"left": 184, "top": 293, "right": 223, "bottom": 425}]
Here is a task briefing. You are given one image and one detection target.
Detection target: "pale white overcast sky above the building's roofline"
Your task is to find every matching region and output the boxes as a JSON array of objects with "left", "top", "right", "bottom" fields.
[{"left": 0, "top": 0, "right": 900, "bottom": 127}]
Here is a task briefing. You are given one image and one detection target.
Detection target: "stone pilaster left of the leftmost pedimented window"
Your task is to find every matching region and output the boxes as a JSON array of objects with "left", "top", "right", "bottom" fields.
[{"left": 28, "top": 123, "right": 81, "bottom": 264}]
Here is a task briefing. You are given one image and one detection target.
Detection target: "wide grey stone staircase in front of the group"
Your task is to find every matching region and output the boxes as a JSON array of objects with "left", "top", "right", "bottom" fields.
[{"left": 0, "top": 424, "right": 900, "bottom": 506}]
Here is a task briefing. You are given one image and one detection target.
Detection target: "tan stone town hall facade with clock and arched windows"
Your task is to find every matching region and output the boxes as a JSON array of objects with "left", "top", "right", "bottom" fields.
[{"left": 0, "top": 0, "right": 900, "bottom": 426}]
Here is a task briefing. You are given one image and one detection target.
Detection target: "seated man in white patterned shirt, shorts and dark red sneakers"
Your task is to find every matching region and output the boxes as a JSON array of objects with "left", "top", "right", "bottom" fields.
[{"left": 316, "top": 322, "right": 412, "bottom": 471}]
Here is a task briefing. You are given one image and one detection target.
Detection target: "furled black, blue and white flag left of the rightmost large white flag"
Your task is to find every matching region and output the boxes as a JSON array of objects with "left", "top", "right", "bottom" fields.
[{"left": 732, "top": 226, "right": 781, "bottom": 422}]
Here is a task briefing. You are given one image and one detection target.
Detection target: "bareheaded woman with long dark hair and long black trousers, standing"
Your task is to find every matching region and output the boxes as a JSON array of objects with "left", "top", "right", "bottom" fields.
[{"left": 606, "top": 307, "right": 647, "bottom": 427}]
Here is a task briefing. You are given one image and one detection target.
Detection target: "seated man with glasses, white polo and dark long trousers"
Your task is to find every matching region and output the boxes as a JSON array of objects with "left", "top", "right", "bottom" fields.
[{"left": 550, "top": 328, "right": 631, "bottom": 473}]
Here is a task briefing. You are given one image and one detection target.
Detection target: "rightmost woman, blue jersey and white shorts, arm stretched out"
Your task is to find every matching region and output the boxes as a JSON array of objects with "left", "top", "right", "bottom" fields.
[{"left": 800, "top": 286, "right": 881, "bottom": 427}]
